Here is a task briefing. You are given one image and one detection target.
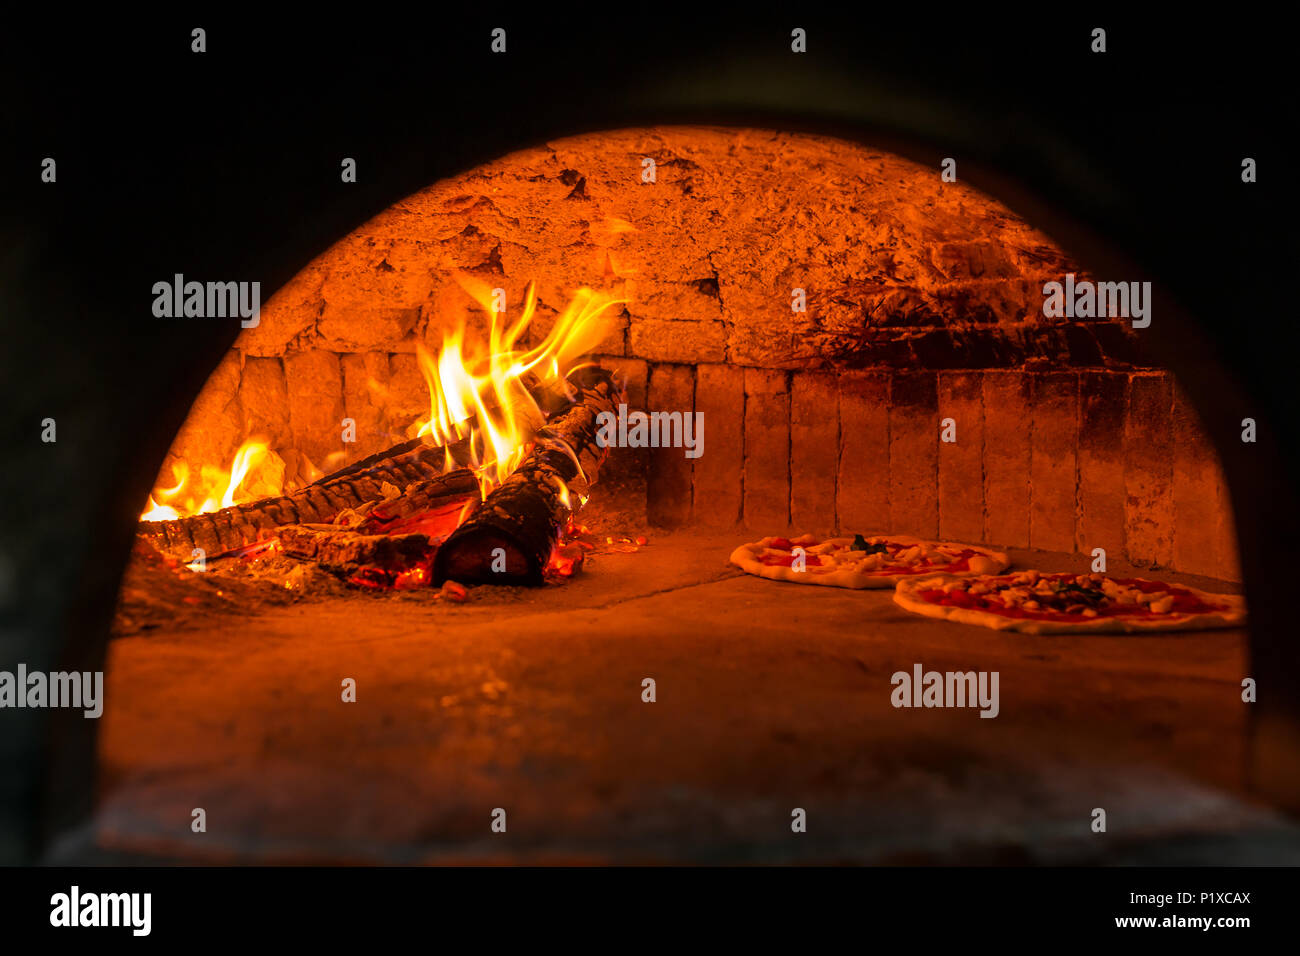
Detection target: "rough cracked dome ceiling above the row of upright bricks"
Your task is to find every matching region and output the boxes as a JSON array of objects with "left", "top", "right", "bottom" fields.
[{"left": 238, "top": 127, "right": 1138, "bottom": 368}]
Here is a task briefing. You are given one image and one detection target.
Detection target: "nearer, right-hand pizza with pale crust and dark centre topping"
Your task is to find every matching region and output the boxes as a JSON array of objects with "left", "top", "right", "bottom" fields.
[{"left": 894, "top": 571, "right": 1245, "bottom": 633}]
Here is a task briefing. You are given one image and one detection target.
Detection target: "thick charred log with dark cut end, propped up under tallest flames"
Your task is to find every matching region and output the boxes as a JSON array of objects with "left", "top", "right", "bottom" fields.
[{"left": 433, "top": 367, "right": 619, "bottom": 585}]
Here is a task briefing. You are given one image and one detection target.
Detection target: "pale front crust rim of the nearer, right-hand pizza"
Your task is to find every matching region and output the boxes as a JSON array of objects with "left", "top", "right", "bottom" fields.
[{"left": 894, "top": 575, "right": 1245, "bottom": 633}]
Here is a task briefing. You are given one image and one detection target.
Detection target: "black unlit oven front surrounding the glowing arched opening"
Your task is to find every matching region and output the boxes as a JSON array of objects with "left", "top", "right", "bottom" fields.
[{"left": 0, "top": 4, "right": 1300, "bottom": 862}]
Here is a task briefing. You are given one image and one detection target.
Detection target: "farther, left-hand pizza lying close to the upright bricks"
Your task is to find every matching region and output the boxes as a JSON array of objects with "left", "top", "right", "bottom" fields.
[{"left": 731, "top": 535, "right": 1011, "bottom": 588}]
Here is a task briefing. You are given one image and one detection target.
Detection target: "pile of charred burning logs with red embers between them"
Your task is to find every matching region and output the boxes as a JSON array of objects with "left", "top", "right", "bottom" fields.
[{"left": 140, "top": 367, "right": 620, "bottom": 588}]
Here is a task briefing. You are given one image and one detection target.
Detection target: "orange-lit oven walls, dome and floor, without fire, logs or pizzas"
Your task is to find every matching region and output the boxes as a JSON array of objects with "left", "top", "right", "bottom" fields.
[{"left": 95, "top": 127, "right": 1283, "bottom": 862}]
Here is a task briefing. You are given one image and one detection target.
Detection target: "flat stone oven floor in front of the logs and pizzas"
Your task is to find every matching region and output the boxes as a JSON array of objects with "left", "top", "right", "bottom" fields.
[{"left": 83, "top": 533, "right": 1300, "bottom": 864}]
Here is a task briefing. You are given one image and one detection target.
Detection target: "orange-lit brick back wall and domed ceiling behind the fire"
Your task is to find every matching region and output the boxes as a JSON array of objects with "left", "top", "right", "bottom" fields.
[{"left": 164, "top": 127, "right": 1238, "bottom": 579}]
